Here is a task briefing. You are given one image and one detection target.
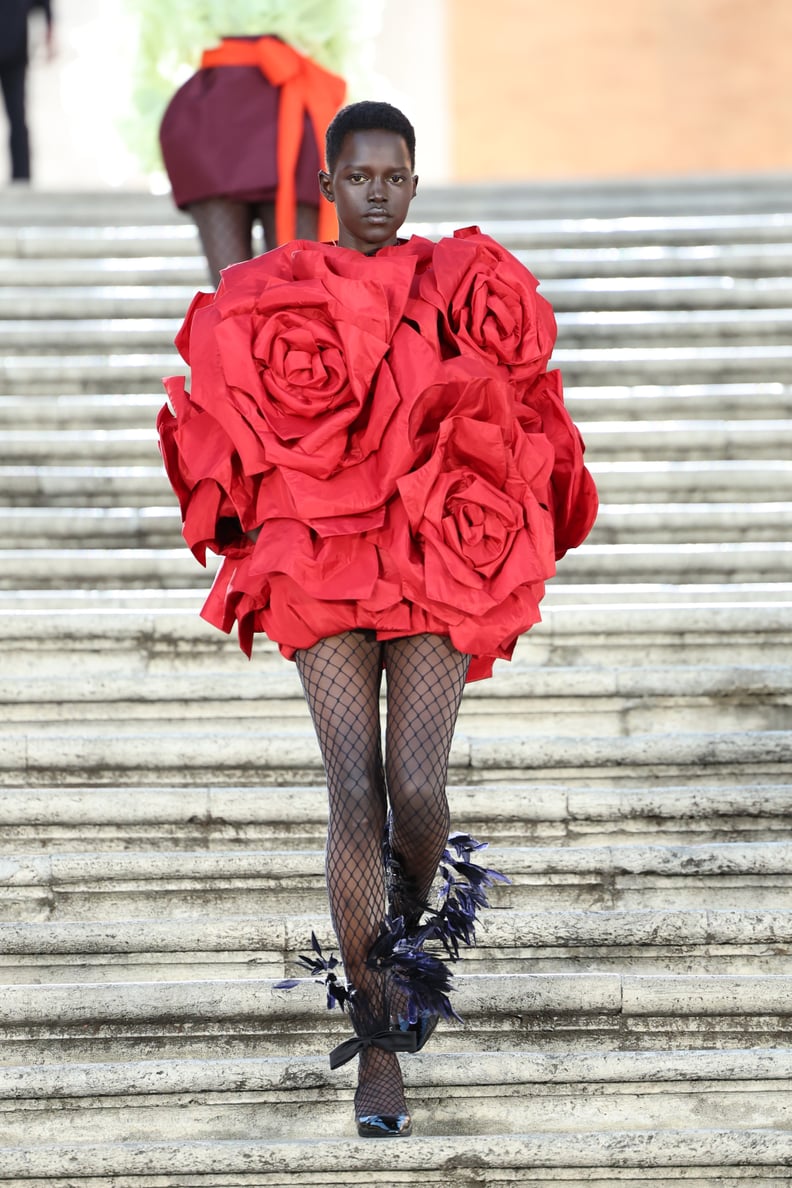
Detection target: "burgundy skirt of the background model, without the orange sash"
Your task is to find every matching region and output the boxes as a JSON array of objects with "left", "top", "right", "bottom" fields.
[{"left": 159, "top": 67, "right": 321, "bottom": 208}]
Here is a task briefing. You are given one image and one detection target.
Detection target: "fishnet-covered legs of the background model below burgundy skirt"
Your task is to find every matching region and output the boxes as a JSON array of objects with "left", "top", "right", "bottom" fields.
[{"left": 189, "top": 198, "right": 318, "bottom": 287}]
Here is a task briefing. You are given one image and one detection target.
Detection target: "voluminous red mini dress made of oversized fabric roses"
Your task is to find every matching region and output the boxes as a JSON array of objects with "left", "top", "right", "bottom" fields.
[{"left": 157, "top": 227, "right": 597, "bottom": 681}]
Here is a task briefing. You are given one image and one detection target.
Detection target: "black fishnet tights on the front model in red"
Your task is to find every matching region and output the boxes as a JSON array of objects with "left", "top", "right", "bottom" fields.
[{"left": 296, "top": 632, "right": 469, "bottom": 1117}]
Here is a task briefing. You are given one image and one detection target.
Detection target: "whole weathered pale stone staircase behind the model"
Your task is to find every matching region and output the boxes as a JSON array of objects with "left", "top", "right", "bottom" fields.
[{"left": 0, "top": 178, "right": 792, "bottom": 1188}]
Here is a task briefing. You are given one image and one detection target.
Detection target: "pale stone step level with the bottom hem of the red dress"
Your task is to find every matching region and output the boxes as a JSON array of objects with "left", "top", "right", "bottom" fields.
[{"left": 0, "top": 594, "right": 792, "bottom": 670}]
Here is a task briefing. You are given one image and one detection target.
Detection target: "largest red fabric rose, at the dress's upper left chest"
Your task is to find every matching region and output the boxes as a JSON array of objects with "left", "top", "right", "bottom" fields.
[{"left": 188, "top": 244, "right": 416, "bottom": 478}]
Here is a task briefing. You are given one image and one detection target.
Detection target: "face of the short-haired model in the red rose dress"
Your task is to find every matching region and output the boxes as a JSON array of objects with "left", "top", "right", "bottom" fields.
[{"left": 319, "top": 128, "right": 418, "bottom": 253}]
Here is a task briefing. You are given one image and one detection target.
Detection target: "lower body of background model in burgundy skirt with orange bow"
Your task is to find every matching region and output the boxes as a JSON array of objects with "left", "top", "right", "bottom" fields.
[{"left": 159, "top": 37, "right": 346, "bottom": 285}]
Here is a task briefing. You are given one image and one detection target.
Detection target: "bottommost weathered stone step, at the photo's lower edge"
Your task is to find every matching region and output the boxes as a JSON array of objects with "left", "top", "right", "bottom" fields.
[{"left": 0, "top": 1127, "right": 792, "bottom": 1188}]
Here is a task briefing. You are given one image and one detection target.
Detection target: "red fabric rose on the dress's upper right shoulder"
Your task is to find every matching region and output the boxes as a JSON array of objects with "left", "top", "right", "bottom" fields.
[{"left": 405, "top": 227, "right": 556, "bottom": 380}]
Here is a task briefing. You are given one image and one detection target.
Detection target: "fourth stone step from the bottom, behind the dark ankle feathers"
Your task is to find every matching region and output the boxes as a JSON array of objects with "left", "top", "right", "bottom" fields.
[{"left": 0, "top": 908, "right": 792, "bottom": 983}]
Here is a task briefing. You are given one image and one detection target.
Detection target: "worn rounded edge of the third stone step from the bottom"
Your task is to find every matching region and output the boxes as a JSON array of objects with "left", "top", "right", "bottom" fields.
[{"left": 0, "top": 973, "right": 792, "bottom": 1031}]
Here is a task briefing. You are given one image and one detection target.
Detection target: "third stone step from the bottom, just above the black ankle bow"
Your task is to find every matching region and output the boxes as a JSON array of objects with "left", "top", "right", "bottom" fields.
[{"left": 0, "top": 973, "right": 792, "bottom": 1064}]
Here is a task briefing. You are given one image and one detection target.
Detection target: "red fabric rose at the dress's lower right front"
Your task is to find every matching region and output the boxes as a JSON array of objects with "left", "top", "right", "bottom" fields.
[{"left": 399, "top": 417, "right": 556, "bottom": 614}]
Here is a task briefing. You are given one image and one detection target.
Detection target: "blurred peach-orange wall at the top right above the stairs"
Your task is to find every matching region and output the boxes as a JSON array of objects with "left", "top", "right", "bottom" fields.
[{"left": 446, "top": 0, "right": 792, "bottom": 179}]
